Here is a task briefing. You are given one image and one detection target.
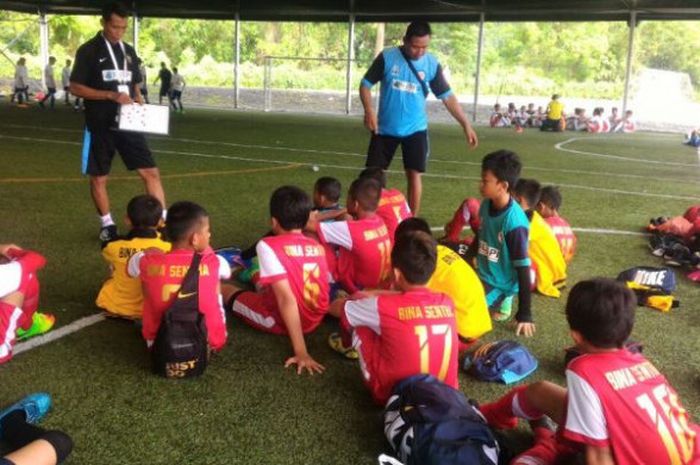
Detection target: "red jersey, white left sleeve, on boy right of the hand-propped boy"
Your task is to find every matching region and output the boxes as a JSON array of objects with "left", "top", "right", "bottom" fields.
[{"left": 318, "top": 215, "right": 392, "bottom": 294}]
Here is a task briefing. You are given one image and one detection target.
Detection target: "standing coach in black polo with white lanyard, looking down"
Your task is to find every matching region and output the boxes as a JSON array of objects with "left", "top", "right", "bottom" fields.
[{"left": 70, "top": 2, "right": 165, "bottom": 241}]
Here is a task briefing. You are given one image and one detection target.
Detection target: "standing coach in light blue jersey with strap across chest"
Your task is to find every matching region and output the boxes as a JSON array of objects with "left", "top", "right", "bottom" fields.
[{"left": 360, "top": 21, "right": 479, "bottom": 215}]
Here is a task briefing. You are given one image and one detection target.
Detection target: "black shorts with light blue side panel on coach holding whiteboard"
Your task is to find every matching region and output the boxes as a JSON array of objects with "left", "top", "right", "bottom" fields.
[{"left": 83, "top": 129, "right": 156, "bottom": 176}]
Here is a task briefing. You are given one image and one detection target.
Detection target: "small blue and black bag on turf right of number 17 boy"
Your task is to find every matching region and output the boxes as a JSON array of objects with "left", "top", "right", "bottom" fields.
[{"left": 464, "top": 341, "right": 537, "bottom": 384}]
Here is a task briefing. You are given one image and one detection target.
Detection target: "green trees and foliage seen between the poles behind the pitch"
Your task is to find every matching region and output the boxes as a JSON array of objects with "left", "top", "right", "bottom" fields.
[{"left": 0, "top": 12, "right": 700, "bottom": 99}]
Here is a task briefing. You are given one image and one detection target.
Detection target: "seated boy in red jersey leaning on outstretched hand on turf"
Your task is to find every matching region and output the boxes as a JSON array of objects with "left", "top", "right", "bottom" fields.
[{"left": 222, "top": 186, "right": 329, "bottom": 374}]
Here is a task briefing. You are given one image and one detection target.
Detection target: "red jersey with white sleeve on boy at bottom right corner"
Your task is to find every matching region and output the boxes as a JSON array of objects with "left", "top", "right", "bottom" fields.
[{"left": 564, "top": 349, "right": 700, "bottom": 465}]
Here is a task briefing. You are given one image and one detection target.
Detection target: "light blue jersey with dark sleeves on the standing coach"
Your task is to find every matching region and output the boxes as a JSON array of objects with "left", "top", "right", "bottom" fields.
[{"left": 362, "top": 47, "right": 452, "bottom": 137}]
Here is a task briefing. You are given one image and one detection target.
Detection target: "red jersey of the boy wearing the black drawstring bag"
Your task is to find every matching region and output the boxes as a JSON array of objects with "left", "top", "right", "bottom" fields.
[{"left": 127, "top": 249, "right": 231, "bottom": 350}]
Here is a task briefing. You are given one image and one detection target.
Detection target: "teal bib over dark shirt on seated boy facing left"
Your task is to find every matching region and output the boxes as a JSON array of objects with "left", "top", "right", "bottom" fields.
[{"left": 476, "top": 198, "right": 530, "bottom": 296}]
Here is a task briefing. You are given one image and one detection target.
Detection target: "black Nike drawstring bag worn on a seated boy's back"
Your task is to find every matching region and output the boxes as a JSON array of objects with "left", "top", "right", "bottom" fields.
[{"left": 151, "top": 253, "right": 209, "bottom": 379}]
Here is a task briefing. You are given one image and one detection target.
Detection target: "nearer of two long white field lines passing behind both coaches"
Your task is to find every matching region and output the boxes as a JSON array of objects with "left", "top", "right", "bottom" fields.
[{"left": 0, "top": 134, "right": 700, "bottom": 202}]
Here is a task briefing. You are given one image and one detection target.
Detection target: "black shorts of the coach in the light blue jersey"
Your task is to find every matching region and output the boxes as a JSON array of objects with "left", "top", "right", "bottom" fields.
[{"left": 365, "top": 131, "right": 430, "bottom": 173}]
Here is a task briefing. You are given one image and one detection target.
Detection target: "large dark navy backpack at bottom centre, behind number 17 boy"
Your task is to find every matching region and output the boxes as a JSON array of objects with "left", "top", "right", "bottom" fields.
[{"left": 384, "top": 375, "right": 501, "bottom": 465}]
